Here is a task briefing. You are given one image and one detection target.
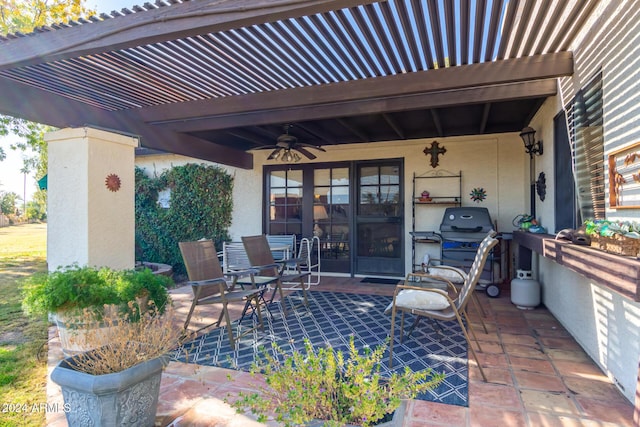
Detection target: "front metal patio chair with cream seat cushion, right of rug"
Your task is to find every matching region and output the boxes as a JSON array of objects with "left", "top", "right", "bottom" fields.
[{"left": 389, "top": 231, "right": 498, "bottom": 382}]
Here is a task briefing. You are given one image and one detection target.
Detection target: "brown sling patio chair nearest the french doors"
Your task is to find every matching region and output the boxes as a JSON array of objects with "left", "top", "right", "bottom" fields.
[{"left": 242, "top": 234, "right": 310, "bottom": 316}]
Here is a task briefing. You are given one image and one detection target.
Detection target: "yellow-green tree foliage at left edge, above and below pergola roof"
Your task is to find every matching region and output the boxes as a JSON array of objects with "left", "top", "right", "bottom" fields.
[{"left": 0, "top": 0, "right": 96, "bottom": 200}]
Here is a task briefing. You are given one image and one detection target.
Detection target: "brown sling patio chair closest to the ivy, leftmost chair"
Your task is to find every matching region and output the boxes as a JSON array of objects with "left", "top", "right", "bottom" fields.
[{"left": 178, "top": 240, "right": 264, "bottom": 347}]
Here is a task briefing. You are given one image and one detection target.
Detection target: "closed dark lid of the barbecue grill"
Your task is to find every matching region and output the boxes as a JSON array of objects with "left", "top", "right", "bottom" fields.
[{"left": 440, "top": 207, "right": 493, "bottom": 242}]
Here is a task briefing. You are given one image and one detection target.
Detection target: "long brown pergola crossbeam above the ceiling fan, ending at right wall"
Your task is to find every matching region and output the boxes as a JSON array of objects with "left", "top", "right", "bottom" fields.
[{"left": 139, "top": 52, "right": 573, "bottom": 130}]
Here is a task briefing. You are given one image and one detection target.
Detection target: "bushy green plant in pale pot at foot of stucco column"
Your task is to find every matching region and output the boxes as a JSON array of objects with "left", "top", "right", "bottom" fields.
[{"left": 22, "top": 265, "right": 172, "bottom": 355}]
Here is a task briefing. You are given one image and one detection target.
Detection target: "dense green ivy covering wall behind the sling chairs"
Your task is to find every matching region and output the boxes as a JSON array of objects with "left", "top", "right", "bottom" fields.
[{"left": 135, "top": 164, "right": 233, "bottom": 274}]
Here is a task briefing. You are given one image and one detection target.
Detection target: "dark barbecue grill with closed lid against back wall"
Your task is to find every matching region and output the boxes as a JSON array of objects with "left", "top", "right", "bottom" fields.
[{"left": 440, "top": 207, "right": 493, "bottom": 281}]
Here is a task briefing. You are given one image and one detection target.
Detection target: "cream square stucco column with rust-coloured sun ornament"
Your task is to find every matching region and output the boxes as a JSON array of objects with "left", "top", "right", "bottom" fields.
[{"left": 45, "top": 127, "right": 138, "bottom": 271}]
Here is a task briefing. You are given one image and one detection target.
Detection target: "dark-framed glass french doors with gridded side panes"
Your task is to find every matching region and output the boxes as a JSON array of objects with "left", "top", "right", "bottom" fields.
[{"left": 264, "top": 160, "right": 404, "bottom": 275}]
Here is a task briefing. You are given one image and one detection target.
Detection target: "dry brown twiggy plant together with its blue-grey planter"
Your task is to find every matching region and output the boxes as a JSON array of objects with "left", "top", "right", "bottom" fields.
[{"left": 51, "top": 302, "right": 186, "bottom": 427}]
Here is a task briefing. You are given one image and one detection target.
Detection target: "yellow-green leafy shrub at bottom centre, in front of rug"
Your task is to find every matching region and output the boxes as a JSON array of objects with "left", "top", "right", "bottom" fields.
[{"left": 232, "top": 337, "right": 444, "bottom": 426}]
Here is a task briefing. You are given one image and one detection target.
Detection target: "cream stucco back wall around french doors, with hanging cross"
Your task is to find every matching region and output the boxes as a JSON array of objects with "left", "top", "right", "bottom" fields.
[{"left": 136, "top": 133, "right": 529, "bottom": 278}]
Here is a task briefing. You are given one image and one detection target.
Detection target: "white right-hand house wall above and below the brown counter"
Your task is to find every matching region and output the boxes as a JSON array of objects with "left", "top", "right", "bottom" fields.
[{"left": 532, "top": 1, "right": 640, "bottom": 402}]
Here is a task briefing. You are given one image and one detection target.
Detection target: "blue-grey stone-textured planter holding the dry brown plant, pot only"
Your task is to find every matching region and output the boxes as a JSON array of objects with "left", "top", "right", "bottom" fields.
[{"left": 51, "top": 357, "right": 168, "bottom": 427}]
